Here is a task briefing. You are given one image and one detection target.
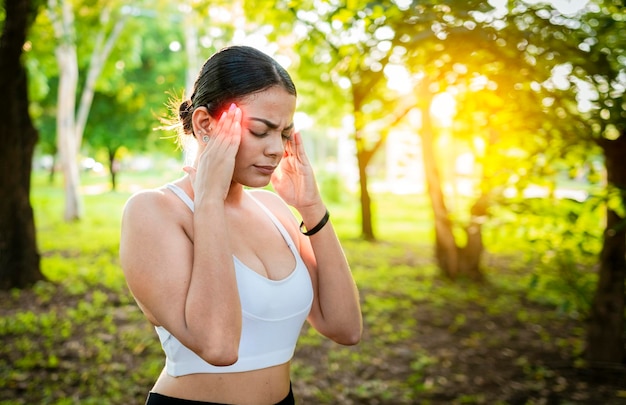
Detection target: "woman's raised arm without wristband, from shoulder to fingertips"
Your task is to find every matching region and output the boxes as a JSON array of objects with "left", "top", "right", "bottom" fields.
[{"left": 120, "top": 105, "right": 242, "bottom": 366}]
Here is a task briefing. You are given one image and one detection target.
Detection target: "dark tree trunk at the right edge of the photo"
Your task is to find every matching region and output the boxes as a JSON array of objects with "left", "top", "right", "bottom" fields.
[{"left": 586, "top": 135, "right": 626, "bottom": 364}]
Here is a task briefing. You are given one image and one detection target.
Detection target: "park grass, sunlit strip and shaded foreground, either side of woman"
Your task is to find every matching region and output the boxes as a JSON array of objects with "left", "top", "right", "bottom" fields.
[{"left": 0, "top": 169, "right": 617, "bottom": 405}]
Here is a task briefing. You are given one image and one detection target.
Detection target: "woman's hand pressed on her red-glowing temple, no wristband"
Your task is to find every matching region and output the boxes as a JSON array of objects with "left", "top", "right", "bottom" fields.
[{"left": 183, "top": 104, "right": 242, "bottom": 203}]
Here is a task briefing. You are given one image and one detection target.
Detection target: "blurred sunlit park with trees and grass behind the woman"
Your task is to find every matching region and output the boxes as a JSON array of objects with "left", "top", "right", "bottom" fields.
[{"left": 0, "top": 0, "right": 626, "bottom": 404}]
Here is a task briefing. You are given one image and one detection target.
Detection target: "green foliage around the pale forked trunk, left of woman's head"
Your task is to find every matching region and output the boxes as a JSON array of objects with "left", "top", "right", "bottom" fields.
[{"left": 27, "top": 0, "right": 241, "bottom": 191}]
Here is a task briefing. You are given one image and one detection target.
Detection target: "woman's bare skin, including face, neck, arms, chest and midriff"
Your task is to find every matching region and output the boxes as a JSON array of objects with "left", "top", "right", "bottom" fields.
[{"left": 120, "top": 87, "right": 362, "bottom": 405}]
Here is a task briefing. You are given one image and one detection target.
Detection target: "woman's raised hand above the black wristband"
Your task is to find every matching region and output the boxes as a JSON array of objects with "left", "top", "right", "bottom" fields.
[{"left": 271, "top": 131, "right": 321, "bottom": 210}]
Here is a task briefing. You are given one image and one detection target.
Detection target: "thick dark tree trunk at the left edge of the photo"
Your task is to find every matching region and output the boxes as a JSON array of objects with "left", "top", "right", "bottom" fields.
[{"left": 0, "top": 0, "right": 44, "bottom": 289}]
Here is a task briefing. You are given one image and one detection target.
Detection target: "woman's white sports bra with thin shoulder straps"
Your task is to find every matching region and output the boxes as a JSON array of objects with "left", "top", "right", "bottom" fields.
[{"left": 155, "top": 184, "right": 313, "bottom": 377}]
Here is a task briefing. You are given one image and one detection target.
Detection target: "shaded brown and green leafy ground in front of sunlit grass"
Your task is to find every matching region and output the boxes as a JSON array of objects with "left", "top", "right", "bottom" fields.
[{"left": 0, "top": 243, "right": 626, "bottom": 405}]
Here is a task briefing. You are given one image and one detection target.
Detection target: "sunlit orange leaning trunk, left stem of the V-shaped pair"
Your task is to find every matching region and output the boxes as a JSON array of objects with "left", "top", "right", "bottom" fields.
[{"left": 421, "top": 103, "right": 459, "bottom": 278}]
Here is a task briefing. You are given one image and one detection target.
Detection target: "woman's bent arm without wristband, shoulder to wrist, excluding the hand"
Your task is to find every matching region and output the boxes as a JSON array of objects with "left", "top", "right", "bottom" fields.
[{"left": 120, "top": 190, "right": 241, "bottom": 366}]
